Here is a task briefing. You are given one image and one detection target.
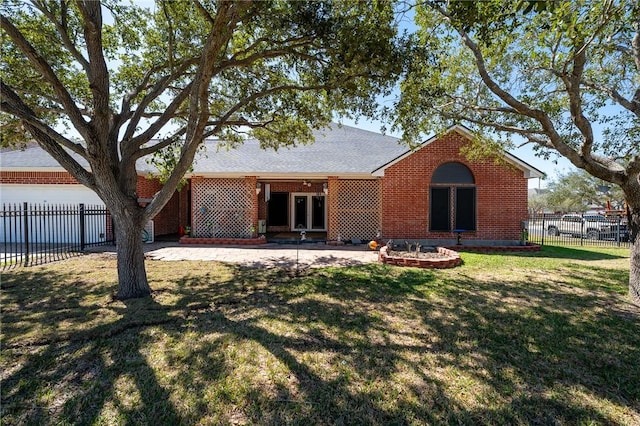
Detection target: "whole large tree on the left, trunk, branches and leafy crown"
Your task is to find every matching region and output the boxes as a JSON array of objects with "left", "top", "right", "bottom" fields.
[{"left": 0, "top": 0, "right": 402, "bottom": 298}]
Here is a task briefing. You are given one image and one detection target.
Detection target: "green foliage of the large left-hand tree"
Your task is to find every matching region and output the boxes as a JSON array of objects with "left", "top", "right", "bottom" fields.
[{"left": 0, "top": 0, "right": 402, "bottom": 166}]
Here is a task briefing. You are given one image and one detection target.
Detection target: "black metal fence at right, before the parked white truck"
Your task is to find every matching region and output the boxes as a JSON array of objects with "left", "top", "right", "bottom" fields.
[{"left": 526, "top": 213, "right": 630, "bottom": 247}]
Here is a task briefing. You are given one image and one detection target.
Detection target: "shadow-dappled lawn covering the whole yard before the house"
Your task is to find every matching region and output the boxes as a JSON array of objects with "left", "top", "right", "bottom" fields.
[{"left": 0, "top": 247, "right": 640, "bottom": 425}]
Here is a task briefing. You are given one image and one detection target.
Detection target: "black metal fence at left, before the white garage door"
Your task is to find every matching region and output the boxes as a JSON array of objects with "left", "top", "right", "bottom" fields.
[{"left": 0, "top": 203, "right": 115, "bottom": 270}]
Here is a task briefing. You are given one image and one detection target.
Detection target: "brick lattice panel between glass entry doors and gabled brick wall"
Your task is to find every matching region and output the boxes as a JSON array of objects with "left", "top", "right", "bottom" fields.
[{"left": 329, "top": 180, "right": 382, "bottom": 240}]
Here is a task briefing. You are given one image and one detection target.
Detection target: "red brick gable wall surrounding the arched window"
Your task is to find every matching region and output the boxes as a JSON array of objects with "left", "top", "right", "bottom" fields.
[{"left": 382, "top": 132, "right": 527, "bottom": 240}]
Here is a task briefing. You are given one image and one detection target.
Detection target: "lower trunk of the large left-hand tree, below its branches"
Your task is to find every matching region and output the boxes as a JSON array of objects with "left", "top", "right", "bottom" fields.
[{"left": 113, "top": 211, "right": 151, "bottom": 300}]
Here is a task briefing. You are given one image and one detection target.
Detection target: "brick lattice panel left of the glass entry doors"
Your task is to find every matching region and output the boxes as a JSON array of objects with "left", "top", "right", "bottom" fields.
[{"left": 192, "top": 179, "right": 255, "bottom": 238}]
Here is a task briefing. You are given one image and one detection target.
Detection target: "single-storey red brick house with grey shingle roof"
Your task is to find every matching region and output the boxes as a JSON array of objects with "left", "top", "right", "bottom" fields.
[{"left": 0, "top": 125, "right": 543, "bottom": 242}]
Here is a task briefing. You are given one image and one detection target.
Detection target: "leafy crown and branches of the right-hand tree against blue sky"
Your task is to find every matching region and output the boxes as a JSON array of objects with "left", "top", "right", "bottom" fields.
[{"left": 390, "top": 0, "right": 640, "bottom": 183}]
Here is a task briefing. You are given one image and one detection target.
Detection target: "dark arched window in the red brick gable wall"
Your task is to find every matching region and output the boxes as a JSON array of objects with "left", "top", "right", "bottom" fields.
[{"left": 429, "top": 162, "right": 476, "bottom": 231}]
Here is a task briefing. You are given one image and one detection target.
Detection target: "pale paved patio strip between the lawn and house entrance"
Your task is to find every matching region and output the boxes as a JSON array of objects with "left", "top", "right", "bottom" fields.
[{"left": 91, "top": 242, "right": 378, "bottom": 268}]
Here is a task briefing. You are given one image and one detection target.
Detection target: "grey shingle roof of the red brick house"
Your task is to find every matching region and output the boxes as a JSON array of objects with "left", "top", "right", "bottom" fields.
[{"left": 0, "top": 124, "right": 544, "bottom": 178}]
